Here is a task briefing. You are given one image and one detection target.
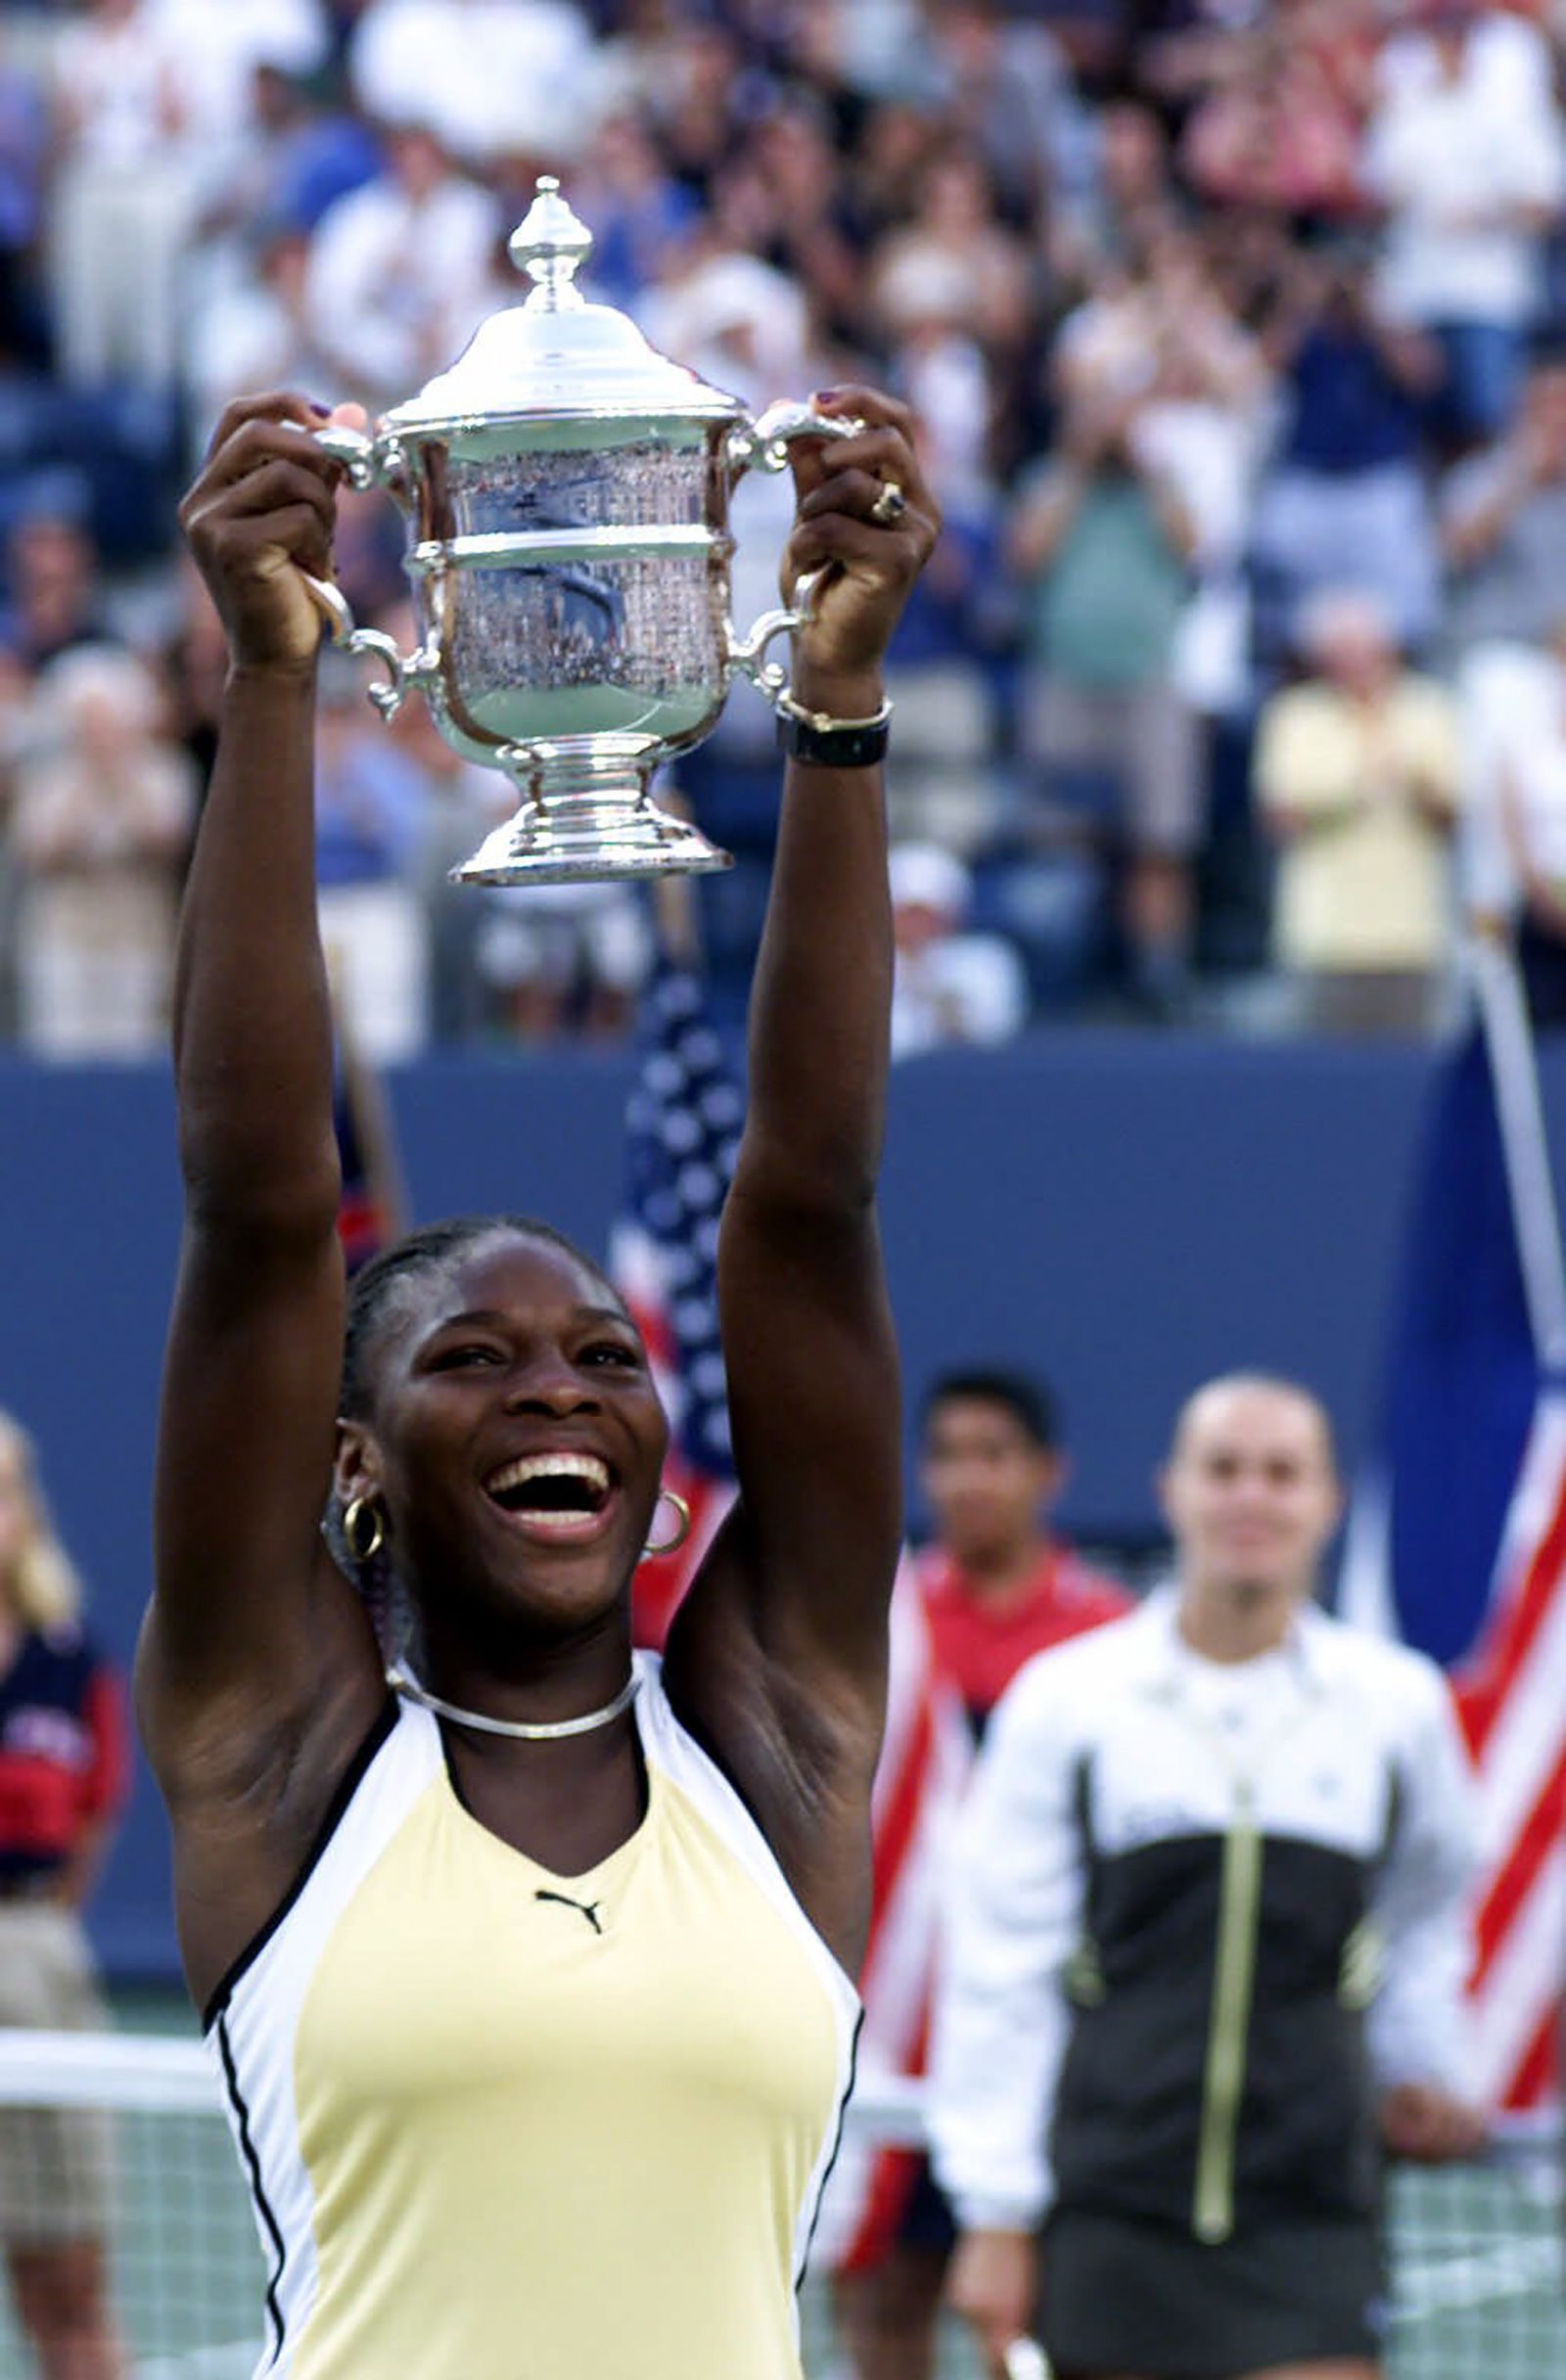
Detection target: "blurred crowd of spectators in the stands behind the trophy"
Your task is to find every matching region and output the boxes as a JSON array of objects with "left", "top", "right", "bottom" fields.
[{"left": 0, "top": 0, "right": 1566, "bottom": 1059}]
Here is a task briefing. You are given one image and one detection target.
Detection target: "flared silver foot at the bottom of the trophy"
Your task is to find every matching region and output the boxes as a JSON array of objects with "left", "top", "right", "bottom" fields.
[{"left": 452, "top": 735, "right": 733, "bottom": 886}]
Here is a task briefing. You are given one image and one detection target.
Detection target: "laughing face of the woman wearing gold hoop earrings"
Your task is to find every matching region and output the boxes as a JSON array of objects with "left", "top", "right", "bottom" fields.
[{"left": 338, "top": 1228, "right": 668, "bottom": 1662}]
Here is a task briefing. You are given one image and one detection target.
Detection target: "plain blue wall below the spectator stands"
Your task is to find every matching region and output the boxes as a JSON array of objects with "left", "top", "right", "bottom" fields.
[{"left": 0, "top": 1032, "right": 1513, "bottom": 1973}]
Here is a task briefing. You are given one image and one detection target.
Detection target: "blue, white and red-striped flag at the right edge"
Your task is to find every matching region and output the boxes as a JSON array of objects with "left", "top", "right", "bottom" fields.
[{"left": 1340, "top": 945, "right": 1566, "bottom": 2109}]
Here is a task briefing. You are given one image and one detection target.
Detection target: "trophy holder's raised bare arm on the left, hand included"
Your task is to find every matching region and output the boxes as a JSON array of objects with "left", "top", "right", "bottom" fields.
[{"left": 138, "top": 397, "right": 381, "bottom": 1973}]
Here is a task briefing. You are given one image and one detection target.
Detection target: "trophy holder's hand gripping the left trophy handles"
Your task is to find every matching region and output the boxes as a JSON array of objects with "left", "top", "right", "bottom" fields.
[{"left": 178, "top": 395, "right": 343, "bottom": 673}]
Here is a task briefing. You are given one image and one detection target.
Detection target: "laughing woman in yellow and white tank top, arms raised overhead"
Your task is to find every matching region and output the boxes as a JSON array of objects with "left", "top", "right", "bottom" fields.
[{"left": 138, "top": 371, "right": 936, "bottom": 2380}]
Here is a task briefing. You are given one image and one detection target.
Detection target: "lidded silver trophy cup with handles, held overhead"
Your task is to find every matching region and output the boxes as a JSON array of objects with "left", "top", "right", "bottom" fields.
[{"left": 309, "top": 176, "right": 859, "bottom": 886}]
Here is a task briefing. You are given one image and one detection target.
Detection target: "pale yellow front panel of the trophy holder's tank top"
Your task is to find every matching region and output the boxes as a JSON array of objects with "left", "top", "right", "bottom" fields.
[{"left": 280, "top": 1759, "right": 840, "bottom": 2380}]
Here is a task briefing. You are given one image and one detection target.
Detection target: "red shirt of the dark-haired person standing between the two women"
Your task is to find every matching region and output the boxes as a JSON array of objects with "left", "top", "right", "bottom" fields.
[{"left": 914, "top": 1544, "right": 1135, "bottom": 1735}]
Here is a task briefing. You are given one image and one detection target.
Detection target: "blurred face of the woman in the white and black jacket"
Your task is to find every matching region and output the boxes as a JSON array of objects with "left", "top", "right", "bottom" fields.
[{"left": 1162, "top": 1381, "right": 1338, "bottom": 1602}]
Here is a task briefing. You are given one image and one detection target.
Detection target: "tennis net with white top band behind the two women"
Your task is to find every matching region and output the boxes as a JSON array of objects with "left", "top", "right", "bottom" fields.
[{"left": 0, "top": 2033, "right": 1566, "bottom": 2380}]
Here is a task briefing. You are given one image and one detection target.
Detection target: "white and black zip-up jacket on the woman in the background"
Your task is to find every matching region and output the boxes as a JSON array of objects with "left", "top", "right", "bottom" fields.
[{"left": 931, "top": 1590, "right": 1473, "bottom": 2237}]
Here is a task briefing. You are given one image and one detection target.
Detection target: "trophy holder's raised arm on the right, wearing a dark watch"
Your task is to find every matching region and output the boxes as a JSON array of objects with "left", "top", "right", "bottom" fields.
[{"left": 668, "top": 388, "right": 936, "bottom": 1894}]
